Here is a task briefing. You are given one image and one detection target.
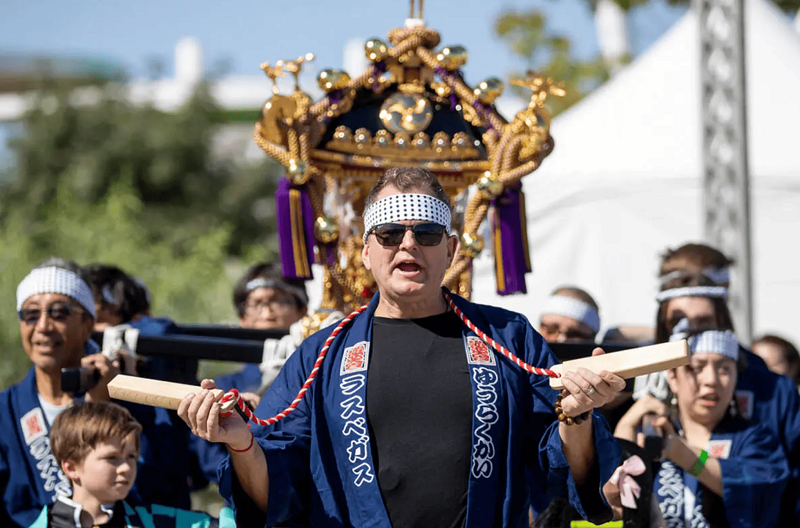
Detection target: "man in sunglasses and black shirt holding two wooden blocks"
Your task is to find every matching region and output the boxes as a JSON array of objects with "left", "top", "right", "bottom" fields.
[{"left": 179, "top": 168, "right": 625, "bottom": 528}]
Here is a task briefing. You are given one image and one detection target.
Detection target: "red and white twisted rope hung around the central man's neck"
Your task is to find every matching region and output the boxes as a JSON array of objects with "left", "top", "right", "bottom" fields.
[{"left": 220, "top": 292, "right": 561, "bottom": 425}]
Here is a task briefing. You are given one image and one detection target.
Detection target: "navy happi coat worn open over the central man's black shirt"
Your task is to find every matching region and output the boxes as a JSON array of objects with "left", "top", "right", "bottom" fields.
[{"left": 220, "top": 295, "right": 620, "bottom": 527}]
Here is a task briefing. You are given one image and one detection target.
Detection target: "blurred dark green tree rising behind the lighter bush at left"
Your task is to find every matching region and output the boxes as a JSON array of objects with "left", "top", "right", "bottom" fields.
[{"left": 0, "top": 79, "right": 277, "bottom": 255}]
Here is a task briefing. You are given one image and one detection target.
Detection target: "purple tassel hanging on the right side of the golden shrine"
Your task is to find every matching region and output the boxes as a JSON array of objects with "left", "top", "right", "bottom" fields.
[{"left": 492, "top": 182, "right": 531, "bottom": 295}]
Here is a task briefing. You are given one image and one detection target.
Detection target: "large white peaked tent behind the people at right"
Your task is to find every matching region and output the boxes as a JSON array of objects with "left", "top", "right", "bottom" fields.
[{"left": 473, "top": 0, "right": 800, "bottom": 342}]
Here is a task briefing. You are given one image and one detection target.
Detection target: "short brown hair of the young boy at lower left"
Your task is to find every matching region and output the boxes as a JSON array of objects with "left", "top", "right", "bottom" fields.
[{"left": 50, "top": 402, "right": 142, "bottom": 465}]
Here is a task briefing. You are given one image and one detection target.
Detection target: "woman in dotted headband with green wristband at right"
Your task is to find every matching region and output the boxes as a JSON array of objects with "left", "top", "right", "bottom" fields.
[{"left": 615, "top": 319, "right": 789, "bottom": 527}]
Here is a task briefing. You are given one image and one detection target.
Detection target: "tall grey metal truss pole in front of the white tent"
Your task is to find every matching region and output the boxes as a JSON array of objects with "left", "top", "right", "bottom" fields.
[{"left": 694, "top": 0, "right": 753, "bottom": 343}]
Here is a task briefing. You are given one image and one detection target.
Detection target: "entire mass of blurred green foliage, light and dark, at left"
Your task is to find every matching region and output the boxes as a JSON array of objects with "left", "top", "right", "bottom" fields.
[{"left": 0, "top": 81, "right": 277, "bottom": 387}]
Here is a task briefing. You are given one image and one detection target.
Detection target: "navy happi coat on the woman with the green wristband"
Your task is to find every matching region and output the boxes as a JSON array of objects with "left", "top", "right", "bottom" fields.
[{"left": 653, "top": 418, "right": 796, "bottom": 528}]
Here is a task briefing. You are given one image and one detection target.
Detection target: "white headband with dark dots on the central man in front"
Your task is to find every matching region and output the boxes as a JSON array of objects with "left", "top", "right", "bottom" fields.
[{"left": 364, "top": 193, "right": 451, "bottom": 244}]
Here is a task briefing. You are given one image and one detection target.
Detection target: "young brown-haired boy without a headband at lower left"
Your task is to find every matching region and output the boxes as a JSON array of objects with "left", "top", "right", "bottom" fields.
[{"left": 30, "top": 402, "right": 235, "bottom": 528}]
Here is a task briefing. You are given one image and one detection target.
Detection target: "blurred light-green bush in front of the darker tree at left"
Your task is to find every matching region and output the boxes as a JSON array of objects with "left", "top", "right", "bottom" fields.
[{"left": 0, "top": 178, "right": 238, "bottom": 387}]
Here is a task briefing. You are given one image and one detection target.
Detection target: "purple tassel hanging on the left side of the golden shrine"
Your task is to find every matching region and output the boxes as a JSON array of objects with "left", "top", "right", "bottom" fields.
[{"left": 275, "top": 178, "right": 314, "bottom": 280}]
